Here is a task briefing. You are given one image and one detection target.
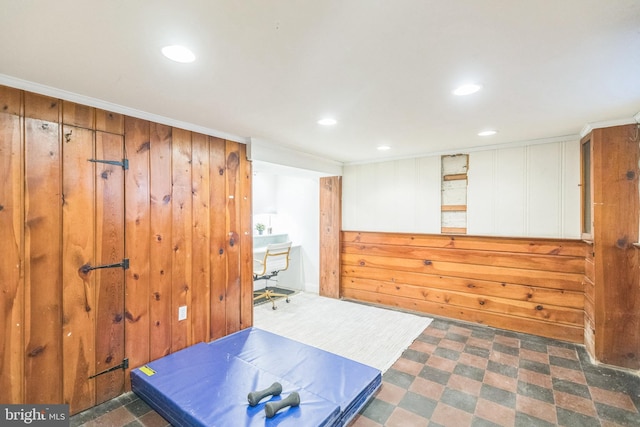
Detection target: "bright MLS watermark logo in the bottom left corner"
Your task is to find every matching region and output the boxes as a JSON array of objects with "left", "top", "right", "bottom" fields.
[{"left": 0, "top": 405, "right": 69, "bottom": 427}]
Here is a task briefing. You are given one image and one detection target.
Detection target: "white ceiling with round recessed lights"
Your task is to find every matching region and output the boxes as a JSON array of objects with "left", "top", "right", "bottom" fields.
[{"left": 0, "top": 0, "right": 640, "bottom": 163}]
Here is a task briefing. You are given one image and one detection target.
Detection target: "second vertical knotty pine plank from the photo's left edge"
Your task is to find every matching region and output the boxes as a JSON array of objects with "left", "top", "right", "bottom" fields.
[{"left": 25, "top": 94, "right": 63, "bottom": 403}]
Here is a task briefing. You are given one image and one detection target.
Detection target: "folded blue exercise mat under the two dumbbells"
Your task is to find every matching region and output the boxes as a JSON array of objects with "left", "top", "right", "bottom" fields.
[{"left": 131, "top": 328, "right": 382, "bottom": 427}]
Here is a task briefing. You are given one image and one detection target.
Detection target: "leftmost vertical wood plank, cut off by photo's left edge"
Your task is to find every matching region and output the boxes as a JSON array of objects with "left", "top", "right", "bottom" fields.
[{"left": 0, "top": 86, "right": 25, "bottom": 404}]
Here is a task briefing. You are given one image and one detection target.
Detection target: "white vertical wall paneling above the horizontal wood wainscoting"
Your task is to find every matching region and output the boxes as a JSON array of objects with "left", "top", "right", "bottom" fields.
[{"left": 343, "top": 139, "right": 580, "bottom": 238}]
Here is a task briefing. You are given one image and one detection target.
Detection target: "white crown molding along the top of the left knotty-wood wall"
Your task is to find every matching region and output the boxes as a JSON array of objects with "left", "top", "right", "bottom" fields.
[{"left": 0, "top": 74, "right": 249, "bottom": 144}]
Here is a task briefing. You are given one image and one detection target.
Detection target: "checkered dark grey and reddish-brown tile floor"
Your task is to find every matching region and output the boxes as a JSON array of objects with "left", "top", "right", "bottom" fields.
[{"left": 71, "top": 319, "right": 640, "bottom": 427}]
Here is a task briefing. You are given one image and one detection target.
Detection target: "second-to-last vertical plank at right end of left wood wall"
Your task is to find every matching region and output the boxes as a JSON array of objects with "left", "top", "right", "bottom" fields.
[{"left": 225, "top": 141, "right": 242, "bottom": 334}]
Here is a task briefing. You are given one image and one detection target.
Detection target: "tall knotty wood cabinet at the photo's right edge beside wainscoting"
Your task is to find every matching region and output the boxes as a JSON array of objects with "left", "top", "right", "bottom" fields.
[{"left": 581, "top": 125, "right": 640, "bottom": 369}]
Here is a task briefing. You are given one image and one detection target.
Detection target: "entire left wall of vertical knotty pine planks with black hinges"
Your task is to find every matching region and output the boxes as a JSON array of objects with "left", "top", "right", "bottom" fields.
[{"left": 0, "top": 86, "right": 253, "bottom": 413}]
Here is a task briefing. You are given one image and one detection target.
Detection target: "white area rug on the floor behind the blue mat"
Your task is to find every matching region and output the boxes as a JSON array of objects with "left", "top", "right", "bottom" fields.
[{"left": 253, "top": 292, "right": 432, "bottom": 372}]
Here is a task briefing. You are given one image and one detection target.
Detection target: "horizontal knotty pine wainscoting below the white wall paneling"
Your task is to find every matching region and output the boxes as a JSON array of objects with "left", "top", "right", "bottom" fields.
[{"left": 340, "top": 231, "right": 586, "bottom": 343}]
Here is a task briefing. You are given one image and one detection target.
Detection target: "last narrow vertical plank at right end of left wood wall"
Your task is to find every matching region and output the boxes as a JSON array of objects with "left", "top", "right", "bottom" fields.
[{"left": 239, "top": 144, "right": 253, "bottom": 329}]
